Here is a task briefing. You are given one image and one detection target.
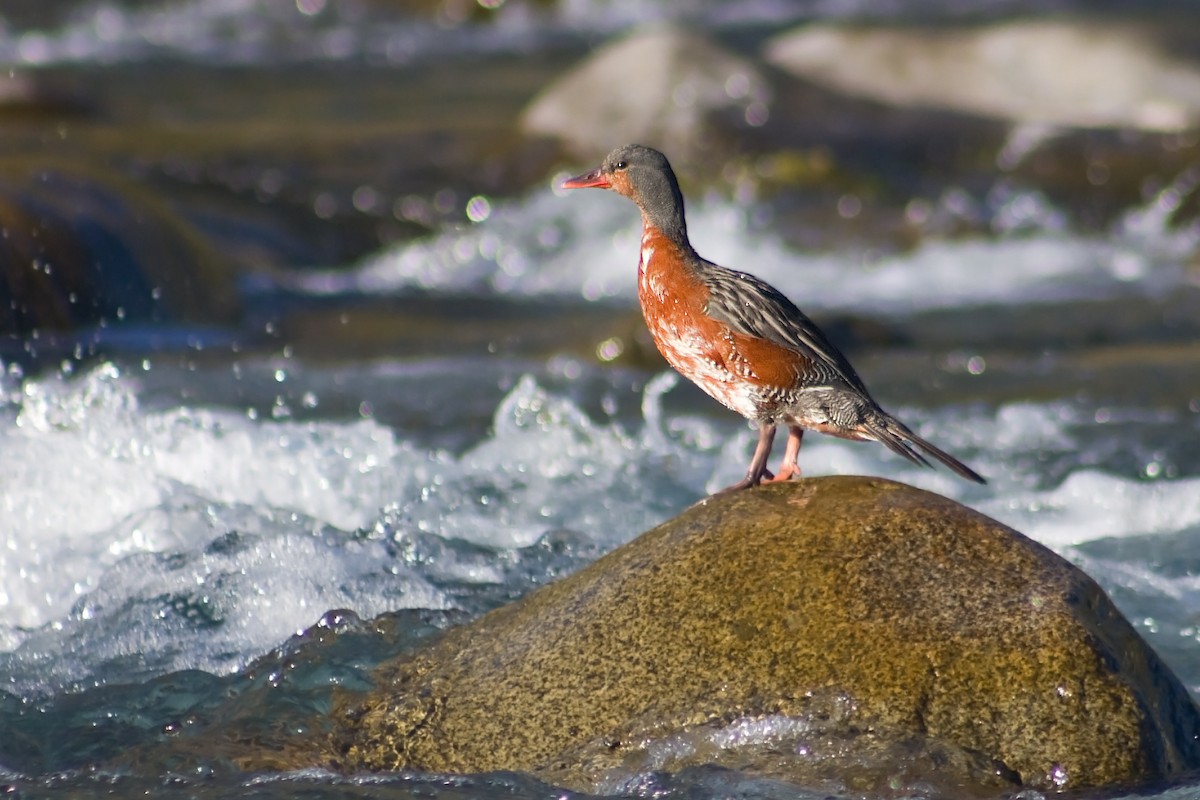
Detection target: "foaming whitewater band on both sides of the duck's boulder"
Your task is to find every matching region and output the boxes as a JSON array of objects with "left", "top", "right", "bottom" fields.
[{"left": 0, "top": 363, "right": 1200, "bottom": 694}]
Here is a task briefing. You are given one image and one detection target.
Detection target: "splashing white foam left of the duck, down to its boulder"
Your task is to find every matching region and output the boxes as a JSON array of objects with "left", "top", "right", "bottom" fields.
[{"left": 0, "top": 365, "right": 700, "bottom": 693}]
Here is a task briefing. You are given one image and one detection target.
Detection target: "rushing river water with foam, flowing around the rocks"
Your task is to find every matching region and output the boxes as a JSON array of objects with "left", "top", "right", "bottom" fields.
[{"left": 0, "top": 0, "right": 1200, "bottom": 798}]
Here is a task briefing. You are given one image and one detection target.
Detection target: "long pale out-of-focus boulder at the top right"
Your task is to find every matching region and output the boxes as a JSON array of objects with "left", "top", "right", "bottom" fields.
[{"left": 766, "top": 20, "right": 1200, "bottom": 131}]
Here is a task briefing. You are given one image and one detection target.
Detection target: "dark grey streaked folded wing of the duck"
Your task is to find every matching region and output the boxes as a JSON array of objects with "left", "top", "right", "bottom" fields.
[{"left": 700, "top": 261, "right": 868, "bottom": 395}]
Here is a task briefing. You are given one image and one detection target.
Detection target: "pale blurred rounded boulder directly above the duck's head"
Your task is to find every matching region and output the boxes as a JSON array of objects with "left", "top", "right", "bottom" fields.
[{"left": 521, "top": 26, "right": 770, "bottom": 160}]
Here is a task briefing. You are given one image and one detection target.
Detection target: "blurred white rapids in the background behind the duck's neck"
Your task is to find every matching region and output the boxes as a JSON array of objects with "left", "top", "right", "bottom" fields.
[{"left": 302, "top": 175, "right": 1200, "bottom": 315}]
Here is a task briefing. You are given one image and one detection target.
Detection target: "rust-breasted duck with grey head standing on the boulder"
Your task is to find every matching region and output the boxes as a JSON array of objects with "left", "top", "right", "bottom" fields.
[{"left": 562, "top": 144, "right": 986, "bottom": 492}]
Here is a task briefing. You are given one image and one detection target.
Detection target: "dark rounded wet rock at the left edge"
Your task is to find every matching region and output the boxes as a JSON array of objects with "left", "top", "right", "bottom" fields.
[{"left": 0, "top": 160, "right": 239, "bottom": 336}]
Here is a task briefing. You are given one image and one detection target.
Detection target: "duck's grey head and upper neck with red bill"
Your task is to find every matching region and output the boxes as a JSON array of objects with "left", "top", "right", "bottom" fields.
[{"left": 563, "top": 144, "right": 690, "bottom": 247}]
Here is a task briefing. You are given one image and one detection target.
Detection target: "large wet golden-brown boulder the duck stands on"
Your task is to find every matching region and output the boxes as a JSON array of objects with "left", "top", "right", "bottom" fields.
[{"left": 338, "top": 477, "right": 1200, "bottom": 794}]
